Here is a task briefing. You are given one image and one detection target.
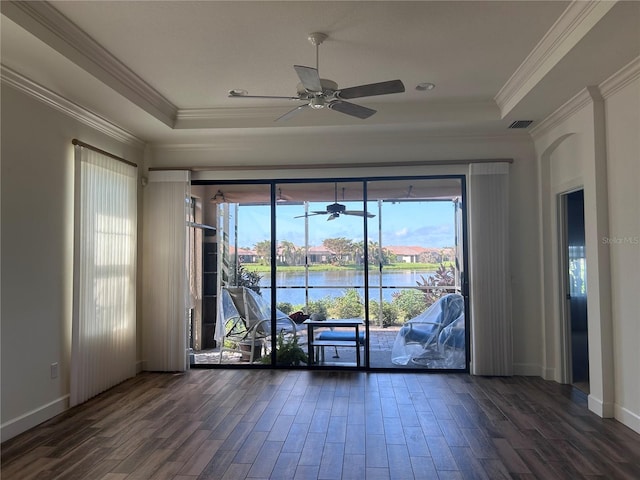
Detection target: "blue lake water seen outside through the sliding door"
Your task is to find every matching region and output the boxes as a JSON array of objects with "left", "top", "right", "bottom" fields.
[{"left": 260, "top": 270, "right": 435, "bottom": 305}]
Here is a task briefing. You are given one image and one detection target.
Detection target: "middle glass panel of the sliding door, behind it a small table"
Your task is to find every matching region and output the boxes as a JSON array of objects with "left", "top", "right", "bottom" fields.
[{"left": 276, "top": 182, "right": 365, "bottom": 365}]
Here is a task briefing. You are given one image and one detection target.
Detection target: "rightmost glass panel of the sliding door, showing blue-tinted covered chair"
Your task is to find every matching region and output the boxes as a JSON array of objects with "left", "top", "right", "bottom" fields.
[{"left": 367, "top": 178, "right": 466, "bottom": 369}]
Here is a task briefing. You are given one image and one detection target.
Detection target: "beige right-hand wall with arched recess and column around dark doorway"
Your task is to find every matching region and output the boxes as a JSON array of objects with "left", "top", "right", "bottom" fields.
[{"left": 533, "top": 60, "right": 640, "bottom": 431}]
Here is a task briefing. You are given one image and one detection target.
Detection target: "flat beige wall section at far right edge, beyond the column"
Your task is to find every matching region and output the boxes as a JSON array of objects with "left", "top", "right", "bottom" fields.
[{"left": 600, "top": 74, "right": 640, "bottom": 432}]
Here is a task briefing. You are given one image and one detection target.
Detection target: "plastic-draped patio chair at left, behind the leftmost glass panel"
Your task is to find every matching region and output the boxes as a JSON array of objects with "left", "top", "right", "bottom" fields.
[{"left": 216, "top": 287, "right": 298, "bottom": 363}]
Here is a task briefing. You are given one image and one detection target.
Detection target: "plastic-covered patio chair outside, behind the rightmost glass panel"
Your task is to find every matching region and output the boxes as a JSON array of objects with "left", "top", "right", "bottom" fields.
[{"left": 391, "top": 293, "right": 464, "bottom": 368}]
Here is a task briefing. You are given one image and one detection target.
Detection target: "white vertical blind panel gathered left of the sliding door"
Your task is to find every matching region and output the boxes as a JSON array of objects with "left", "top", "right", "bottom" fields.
[{"left": 143, "top": 172, "right": 190, "bottom": 372}]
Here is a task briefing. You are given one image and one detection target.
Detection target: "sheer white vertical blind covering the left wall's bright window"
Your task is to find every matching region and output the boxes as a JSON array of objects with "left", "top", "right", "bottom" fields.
[{"left": 71, "top": 145, "right": 137, "bottom": 406}]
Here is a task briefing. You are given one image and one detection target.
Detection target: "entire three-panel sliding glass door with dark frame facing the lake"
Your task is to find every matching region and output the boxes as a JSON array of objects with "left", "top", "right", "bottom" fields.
[{"left": 189, "top": 177, "right": 467, "bottom": 370}]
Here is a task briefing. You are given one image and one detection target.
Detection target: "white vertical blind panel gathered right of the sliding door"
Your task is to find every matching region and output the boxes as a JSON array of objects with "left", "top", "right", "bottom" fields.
[{"left": 469, "top": 163, "right": 513, "bottom": 375}]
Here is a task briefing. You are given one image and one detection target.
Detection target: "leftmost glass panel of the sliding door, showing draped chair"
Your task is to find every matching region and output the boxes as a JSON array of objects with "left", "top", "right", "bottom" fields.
[{"left": 208, "top": 184, "right": 272, "bottom": 365}]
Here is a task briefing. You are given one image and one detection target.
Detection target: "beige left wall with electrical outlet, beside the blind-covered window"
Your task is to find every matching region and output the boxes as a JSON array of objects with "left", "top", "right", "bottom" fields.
[{"left": 0, "top": 83, "right": 142, "bottom": 440}]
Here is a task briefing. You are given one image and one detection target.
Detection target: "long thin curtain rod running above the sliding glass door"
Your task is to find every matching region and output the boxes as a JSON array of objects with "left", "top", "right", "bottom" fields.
[{"left": 149, "top": 158, "right": 513, "bottom": 172}]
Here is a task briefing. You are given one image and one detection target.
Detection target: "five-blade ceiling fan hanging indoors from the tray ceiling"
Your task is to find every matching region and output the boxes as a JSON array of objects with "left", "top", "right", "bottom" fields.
[{"left": 229, "top": 32, "right": 404, "bottom": 121}]
